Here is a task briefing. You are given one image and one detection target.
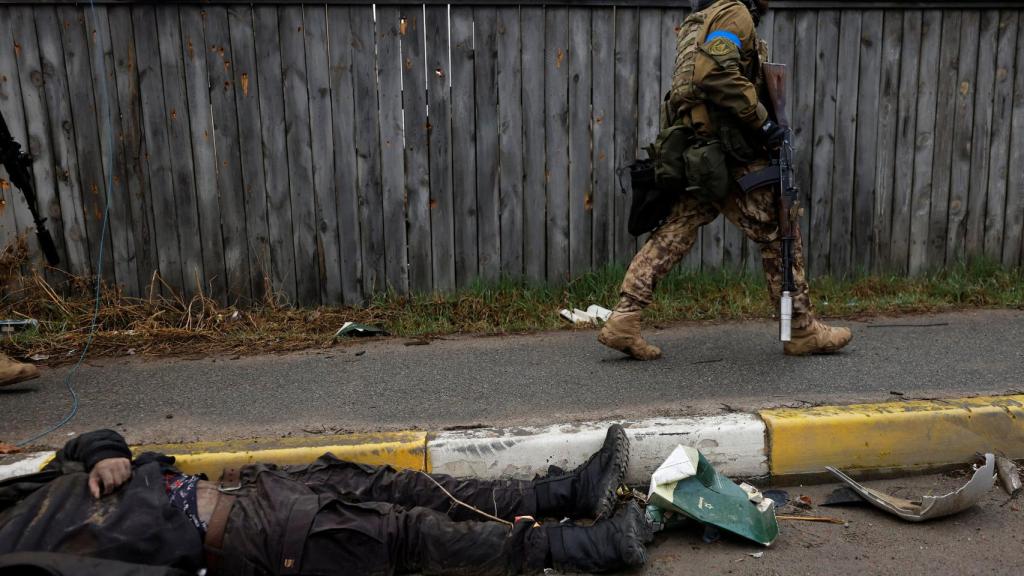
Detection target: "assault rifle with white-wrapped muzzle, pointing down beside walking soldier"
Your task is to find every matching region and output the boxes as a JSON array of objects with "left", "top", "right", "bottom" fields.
[{"left": 739, "top": 64, "right": 800, "bottom": 342}]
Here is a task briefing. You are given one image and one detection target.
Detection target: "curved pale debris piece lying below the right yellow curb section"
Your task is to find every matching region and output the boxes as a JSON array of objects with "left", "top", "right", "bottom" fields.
[{"left": 825, "top": 454, "right": 995, "bottom": 522}]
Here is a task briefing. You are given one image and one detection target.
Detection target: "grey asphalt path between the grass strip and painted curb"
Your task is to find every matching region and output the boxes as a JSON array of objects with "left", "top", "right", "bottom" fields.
[{"left": 0, "top": 311, "right": 1024, "bottom": 446}]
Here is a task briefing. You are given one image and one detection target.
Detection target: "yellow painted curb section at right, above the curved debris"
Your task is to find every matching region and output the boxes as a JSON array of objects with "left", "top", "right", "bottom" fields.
[{"left": 761, "top": 396, "right": 1024, "bottom": 477}]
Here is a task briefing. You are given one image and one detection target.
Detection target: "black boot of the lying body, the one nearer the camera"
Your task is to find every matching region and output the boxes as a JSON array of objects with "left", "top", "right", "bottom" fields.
[{"left": 541, "top": 502, "right": 654, "bottom": 573}]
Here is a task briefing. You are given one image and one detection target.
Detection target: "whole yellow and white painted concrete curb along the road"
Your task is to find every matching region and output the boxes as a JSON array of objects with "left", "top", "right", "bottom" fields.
[{"left": 6, "top": 395, "right": 1024, "bottom": 485}]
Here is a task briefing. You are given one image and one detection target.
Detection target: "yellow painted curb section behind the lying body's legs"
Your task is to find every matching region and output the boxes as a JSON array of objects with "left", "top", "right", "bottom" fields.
[{"left": 132, "top": 431, "right": 430, "bottom": 480}]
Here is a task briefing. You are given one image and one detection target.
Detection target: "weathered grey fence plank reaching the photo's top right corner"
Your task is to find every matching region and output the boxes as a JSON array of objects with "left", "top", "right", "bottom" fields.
[{"left": 985, "top": 10, "right": 1024, "bottom": 260}]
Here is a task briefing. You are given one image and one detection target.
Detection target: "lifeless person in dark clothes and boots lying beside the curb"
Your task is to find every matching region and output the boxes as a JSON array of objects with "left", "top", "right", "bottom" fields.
[{"left": 0, "top": 426, "right": 650, "bottom": 576}]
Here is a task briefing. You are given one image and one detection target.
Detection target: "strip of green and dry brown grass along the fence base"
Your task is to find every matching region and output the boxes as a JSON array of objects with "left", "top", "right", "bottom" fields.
[{"left": 0, "top": 247, "right": 1024, "bottom": 364}]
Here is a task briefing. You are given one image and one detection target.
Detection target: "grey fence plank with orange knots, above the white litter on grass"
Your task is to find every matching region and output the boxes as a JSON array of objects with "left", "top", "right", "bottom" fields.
[{"left": 568, "top": 8, "right": 600, "bottom": 277}]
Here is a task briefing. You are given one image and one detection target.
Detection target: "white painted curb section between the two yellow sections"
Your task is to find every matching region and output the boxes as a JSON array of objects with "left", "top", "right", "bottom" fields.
[{"left": 427, "top": 414, "right": 768, "bottom": 486}]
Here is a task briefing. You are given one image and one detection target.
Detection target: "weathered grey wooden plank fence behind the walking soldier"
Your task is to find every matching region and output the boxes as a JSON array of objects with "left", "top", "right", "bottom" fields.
[{"left": 0, "top": 0, "right": 1024, "bottom": 305}]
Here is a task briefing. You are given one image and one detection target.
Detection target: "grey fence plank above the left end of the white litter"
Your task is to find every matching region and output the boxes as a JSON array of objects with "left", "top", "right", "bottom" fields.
[{"left": 544, "top": 7, "right": 569, "bottom": 282}]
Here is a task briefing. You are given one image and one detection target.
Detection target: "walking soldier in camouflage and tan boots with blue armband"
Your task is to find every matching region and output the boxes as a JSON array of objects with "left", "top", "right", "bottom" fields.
[{"left": 598, "top": 0, "right": 852, "bottom": 360}]
